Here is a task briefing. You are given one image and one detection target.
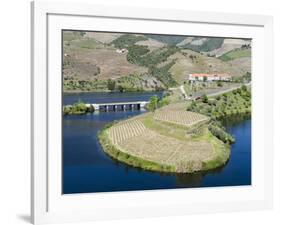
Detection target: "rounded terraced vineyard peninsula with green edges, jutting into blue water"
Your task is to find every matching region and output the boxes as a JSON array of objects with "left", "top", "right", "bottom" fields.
[{"left": 102, "top": 107, "right": 229, "bottom": 173}]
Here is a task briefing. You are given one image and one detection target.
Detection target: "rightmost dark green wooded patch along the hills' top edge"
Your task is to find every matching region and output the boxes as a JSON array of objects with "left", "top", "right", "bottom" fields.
[{"left": 183, "top": 38, "right": 224, "bottom": 52}]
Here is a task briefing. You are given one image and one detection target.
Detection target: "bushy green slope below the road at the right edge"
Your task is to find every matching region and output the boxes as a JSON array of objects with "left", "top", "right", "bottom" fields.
[{"left": 187, "top": 86, "right": 251, "bottom": 120}]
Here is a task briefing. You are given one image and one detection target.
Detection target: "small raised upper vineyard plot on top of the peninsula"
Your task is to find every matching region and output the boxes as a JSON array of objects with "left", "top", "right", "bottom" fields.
[{"left": 153, "top": 110, "right": 208, "bottom": 127}]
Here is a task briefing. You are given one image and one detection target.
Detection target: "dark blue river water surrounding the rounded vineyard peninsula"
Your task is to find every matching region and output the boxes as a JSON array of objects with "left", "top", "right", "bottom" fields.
[{"left": 63, "top": 93, "right": 251, "bottom": 194}]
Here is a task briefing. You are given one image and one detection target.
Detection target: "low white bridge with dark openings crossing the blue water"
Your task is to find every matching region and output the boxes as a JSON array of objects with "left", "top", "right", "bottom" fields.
[{"left": 86, "top": 101, "right": 148, "bottom": 111}]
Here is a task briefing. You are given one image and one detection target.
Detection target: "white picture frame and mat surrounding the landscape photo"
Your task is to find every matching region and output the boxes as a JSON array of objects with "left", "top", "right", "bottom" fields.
[{"left": 31, "top": 1, "right": 273, "bottom": 224}]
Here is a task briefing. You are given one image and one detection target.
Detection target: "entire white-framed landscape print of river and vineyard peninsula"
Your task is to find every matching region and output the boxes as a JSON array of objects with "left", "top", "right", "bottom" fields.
[{"left": 31, "top": 1, "right": 273, "bottom": 224}]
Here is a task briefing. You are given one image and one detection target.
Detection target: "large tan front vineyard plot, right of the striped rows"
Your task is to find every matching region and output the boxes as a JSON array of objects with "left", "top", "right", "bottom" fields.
[{"left": 119, "top": 130, "right": 213, "bottom": 172}]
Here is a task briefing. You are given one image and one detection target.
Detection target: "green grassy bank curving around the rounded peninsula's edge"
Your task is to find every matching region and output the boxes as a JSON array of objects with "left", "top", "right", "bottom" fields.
[{"left": 98, "top": 109, "right": 231, "bottom": 174}]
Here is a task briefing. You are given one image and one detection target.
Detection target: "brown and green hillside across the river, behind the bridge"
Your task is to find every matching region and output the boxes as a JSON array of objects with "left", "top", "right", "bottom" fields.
[{"left": 63, "top": 31, "right": 251, "bottom": 91}]
